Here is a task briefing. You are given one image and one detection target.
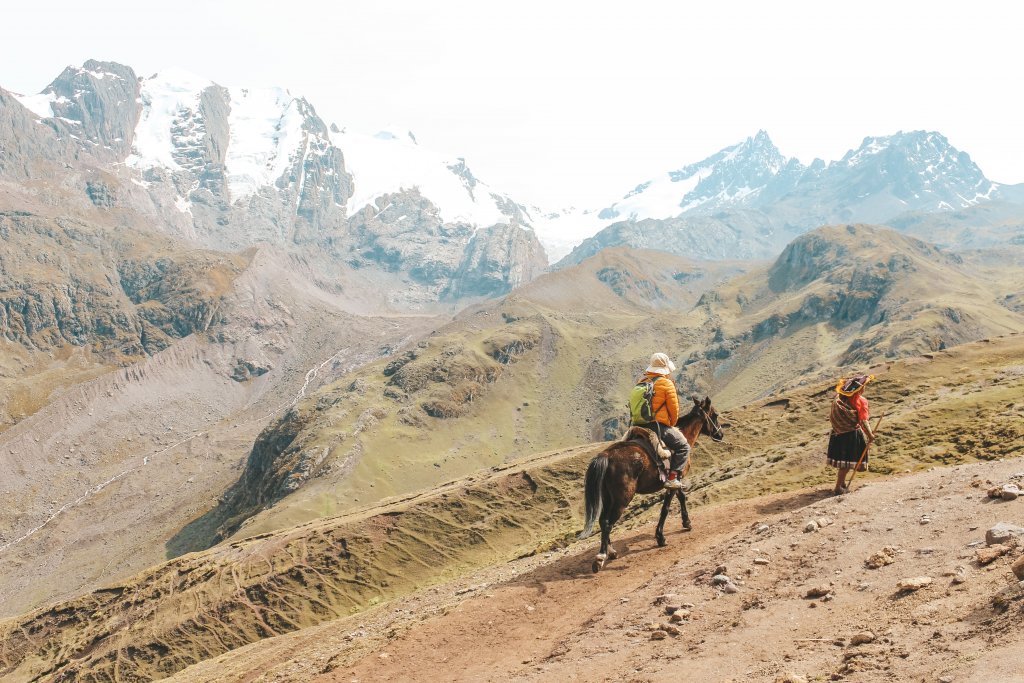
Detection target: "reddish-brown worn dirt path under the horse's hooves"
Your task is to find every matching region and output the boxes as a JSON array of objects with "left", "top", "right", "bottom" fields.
[{"left": 324, "top": 496, "right": 770, "bottom": 681}]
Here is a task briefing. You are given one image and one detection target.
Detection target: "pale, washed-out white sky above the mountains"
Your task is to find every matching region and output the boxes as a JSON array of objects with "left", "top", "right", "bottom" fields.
[{"left": 0, "top": 0, "right": 1024, "bottom": 207}]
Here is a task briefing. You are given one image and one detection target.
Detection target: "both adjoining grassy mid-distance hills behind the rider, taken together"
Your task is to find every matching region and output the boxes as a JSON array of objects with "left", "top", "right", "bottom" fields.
[{"left": 197, "top": 226, "right": 1024, "bottom": 549}]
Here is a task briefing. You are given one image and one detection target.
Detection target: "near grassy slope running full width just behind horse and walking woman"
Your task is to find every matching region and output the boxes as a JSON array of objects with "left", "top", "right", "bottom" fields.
[{"left": 0, "top": 334, "right": 1024, "bottom": 680}]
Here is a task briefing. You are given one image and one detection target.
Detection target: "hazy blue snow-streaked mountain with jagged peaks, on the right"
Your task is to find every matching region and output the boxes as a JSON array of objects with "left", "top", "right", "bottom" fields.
[{"left": 564, "top": 131, "right": 1020, "bottom": 263}]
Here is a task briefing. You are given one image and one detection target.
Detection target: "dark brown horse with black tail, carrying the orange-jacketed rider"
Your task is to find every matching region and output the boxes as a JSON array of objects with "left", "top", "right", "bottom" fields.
[{"left": 578, "top": 396, "right": 724, "bottom": 572}]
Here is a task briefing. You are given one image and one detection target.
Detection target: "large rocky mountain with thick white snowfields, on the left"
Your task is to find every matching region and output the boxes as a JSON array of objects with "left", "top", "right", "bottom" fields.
[{"left": 0, "top": 60, "right": 546, "bottom": 299}]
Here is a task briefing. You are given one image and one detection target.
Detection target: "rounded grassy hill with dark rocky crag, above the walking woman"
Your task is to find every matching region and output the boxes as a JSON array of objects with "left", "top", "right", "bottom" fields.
[{"left": 688, "top": 225, "right": 1024, "bottom": 405}]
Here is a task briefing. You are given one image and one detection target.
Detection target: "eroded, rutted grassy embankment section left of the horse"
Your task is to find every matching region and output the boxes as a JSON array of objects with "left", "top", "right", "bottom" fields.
[{"left": 0, "top": 447, "right": 590, "bottom": 680}]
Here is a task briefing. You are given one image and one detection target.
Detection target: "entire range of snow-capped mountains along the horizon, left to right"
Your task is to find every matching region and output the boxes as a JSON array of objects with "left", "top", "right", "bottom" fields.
[{"left": 0, "top": 60, "right": 1024, "bottom": 280}]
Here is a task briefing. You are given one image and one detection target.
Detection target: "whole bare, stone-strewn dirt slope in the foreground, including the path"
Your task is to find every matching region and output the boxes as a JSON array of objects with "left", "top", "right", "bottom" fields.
[{"left": 173, "top": 457, "right": 1024, "bottom": 683}]
